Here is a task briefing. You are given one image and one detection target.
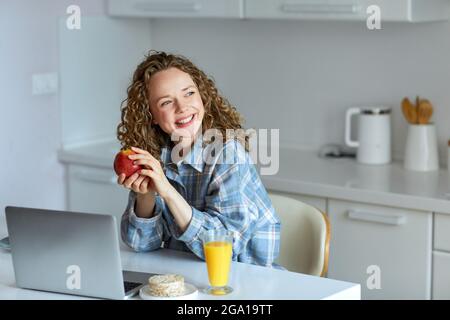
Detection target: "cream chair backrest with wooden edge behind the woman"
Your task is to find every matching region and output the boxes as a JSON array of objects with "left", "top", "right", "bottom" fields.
[{"left": 269, "top": 193, "right": 330, "bottom": 276}]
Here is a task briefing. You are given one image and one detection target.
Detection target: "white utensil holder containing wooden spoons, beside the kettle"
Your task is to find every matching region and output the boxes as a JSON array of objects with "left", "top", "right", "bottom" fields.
[{"left": 404, "top": 123, "right": 439, "bottom": 171}]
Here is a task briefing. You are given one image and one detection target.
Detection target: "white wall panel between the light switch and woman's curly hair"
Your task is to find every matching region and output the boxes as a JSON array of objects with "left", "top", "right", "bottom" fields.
[{"left": 59, "top": 16, "right": 151, "bottom": 148}]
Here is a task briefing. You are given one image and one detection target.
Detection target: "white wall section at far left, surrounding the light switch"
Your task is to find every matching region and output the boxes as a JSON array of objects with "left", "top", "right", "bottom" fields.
[{"left": 0, "top": 0, "right": 104, "bottom": 216}]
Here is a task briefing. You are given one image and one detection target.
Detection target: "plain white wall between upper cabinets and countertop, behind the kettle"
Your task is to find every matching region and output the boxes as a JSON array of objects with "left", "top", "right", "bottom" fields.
[{"left": 152, "top": 19, "right": 450, "bottom": 165}]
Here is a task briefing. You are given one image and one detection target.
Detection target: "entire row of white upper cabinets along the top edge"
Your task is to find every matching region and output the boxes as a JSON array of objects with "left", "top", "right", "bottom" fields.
[{"left": 107, "top": 0, "right": 450, "bottom": 22}]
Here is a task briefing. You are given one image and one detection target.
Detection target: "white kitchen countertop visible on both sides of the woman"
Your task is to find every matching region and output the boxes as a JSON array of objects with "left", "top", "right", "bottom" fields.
[{"left": 59, "top": 141, "right": 450, "bottom": 214}]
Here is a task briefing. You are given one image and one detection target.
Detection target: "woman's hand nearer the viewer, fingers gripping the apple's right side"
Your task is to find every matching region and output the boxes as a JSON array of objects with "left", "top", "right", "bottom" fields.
[{"left": 122, "top": 147, "right": 172, "bottom": 198}]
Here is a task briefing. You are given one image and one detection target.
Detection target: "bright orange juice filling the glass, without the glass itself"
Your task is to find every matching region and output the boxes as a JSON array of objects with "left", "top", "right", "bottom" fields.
[{"left": 204, "top": 241, "right": 232, "bottom": 287}]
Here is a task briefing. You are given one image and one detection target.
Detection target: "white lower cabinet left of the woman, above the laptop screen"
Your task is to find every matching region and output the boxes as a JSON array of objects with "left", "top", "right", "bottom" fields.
[{"left": 68, "top": 165, "right": 128, "bottom": 237}]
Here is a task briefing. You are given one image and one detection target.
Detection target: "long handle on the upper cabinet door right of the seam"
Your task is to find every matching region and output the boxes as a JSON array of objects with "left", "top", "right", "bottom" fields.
[{"left": 281, "top": 3, "right": 361, "bottom": 14}]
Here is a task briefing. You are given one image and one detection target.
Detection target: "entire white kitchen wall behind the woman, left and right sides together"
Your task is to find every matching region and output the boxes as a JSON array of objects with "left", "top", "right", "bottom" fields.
[{"left": 0, "top": 0, "right": 450, "bottom": 214}]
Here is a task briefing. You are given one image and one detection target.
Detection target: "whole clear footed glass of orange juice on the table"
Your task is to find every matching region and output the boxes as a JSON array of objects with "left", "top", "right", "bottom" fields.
[{"left": 202, "top": 230, "right": 233, "bottom": 295}]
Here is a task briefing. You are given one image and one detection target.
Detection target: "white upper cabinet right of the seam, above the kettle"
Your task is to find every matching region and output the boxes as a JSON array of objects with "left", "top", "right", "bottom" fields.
[{"left": 245, "top": 0, "right": 450, "bottom": 22}]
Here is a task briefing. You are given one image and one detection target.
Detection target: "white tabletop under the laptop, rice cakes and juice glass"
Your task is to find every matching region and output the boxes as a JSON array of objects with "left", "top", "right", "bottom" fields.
[{"left": 0, "top": 216, "right": 361, "bottom": 300}]
